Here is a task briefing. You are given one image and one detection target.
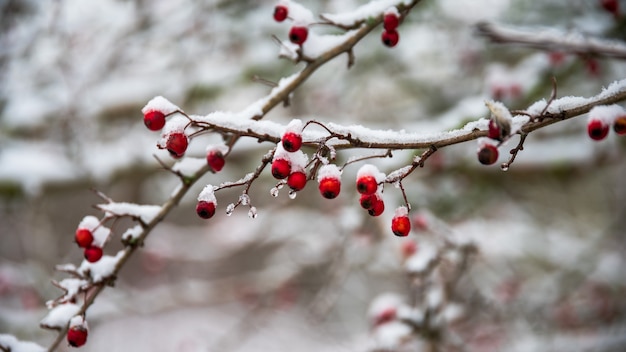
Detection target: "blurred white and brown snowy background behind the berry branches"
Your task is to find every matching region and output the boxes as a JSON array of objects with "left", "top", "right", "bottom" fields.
[{"left": 0, "top": 0, "right": 626, "bottom": 352}]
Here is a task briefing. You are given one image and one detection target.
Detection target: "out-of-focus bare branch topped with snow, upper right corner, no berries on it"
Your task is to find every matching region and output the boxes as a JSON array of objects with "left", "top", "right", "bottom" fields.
[{"left": 476, "top": 22, "right": 626, "bottom": 59}]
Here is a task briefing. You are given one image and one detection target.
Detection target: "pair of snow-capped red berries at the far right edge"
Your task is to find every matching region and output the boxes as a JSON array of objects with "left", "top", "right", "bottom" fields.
[{"left": 587, "top": 105, "right": 626, "bottom": 141}]
